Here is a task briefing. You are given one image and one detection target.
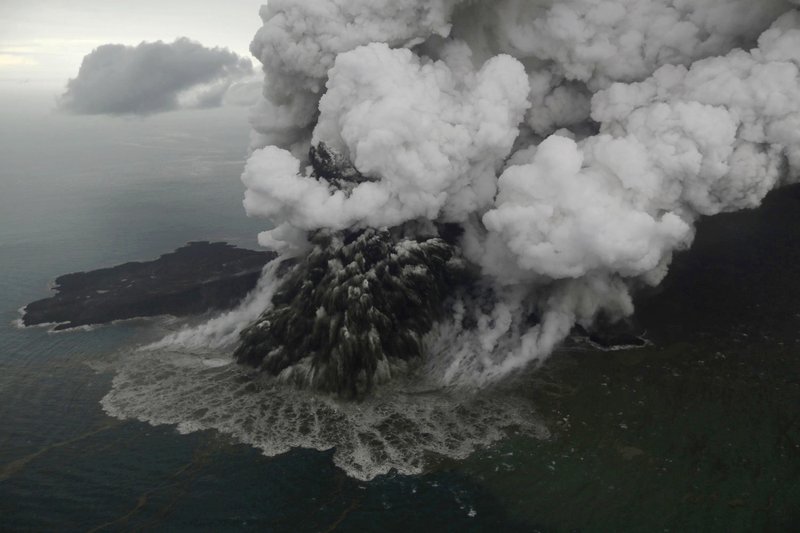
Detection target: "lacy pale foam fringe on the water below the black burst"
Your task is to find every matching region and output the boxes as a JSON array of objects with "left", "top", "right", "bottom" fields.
[{"left": 101, "top": 342, "right": 548, "bottom": 480}]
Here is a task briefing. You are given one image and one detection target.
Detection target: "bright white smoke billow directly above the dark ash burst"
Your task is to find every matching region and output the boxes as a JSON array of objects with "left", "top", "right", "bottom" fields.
[{"left": 243, "top": 44, "right": 528, "bottom": 247}]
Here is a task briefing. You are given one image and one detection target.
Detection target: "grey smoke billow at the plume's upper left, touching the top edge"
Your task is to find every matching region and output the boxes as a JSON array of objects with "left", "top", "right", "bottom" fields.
[{"left": 250, "top": 0, "right": 459, "bottom": 152}]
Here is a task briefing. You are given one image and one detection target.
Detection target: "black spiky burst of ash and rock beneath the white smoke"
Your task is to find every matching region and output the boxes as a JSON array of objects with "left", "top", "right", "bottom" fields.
[{"left": 236, "top": 229, "right": 465, "bottom": 398}]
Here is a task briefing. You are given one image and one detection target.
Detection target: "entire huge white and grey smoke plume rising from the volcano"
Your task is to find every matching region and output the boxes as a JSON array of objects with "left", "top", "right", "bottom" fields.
[{"left": 238, "top": 0, "right": 800, "bottom": 383}]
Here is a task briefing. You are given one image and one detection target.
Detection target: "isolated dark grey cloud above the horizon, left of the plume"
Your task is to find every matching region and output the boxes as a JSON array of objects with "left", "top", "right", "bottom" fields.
[{"left": 58, "top": 37, "right": 253, "bottom": 115}]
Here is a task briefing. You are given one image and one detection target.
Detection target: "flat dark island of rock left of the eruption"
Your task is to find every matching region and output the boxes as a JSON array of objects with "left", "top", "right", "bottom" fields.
[{"left": 22, "top": 241, "right": 275, "bottom": 330}]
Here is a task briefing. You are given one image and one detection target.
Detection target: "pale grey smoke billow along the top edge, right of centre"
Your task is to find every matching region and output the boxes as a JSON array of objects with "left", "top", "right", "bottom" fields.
[{"left": 454, "top": 0, "right": 789, "bottom": 86}]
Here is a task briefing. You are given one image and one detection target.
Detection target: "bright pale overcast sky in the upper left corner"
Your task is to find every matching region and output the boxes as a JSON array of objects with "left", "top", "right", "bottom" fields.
[{"left": 0, "top": 0, "right": 265, "bottom": 88}]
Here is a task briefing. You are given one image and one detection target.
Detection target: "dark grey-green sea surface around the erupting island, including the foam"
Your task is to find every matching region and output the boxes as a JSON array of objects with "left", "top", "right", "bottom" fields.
[{"left": 0, "top": 97, "right": 800, "bottom": 532}]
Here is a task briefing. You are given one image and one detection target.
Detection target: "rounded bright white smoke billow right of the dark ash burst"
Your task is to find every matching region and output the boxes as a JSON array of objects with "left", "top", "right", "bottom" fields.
[{"left": 483, "top": 136, "right": 691, "bottom": 279}]
